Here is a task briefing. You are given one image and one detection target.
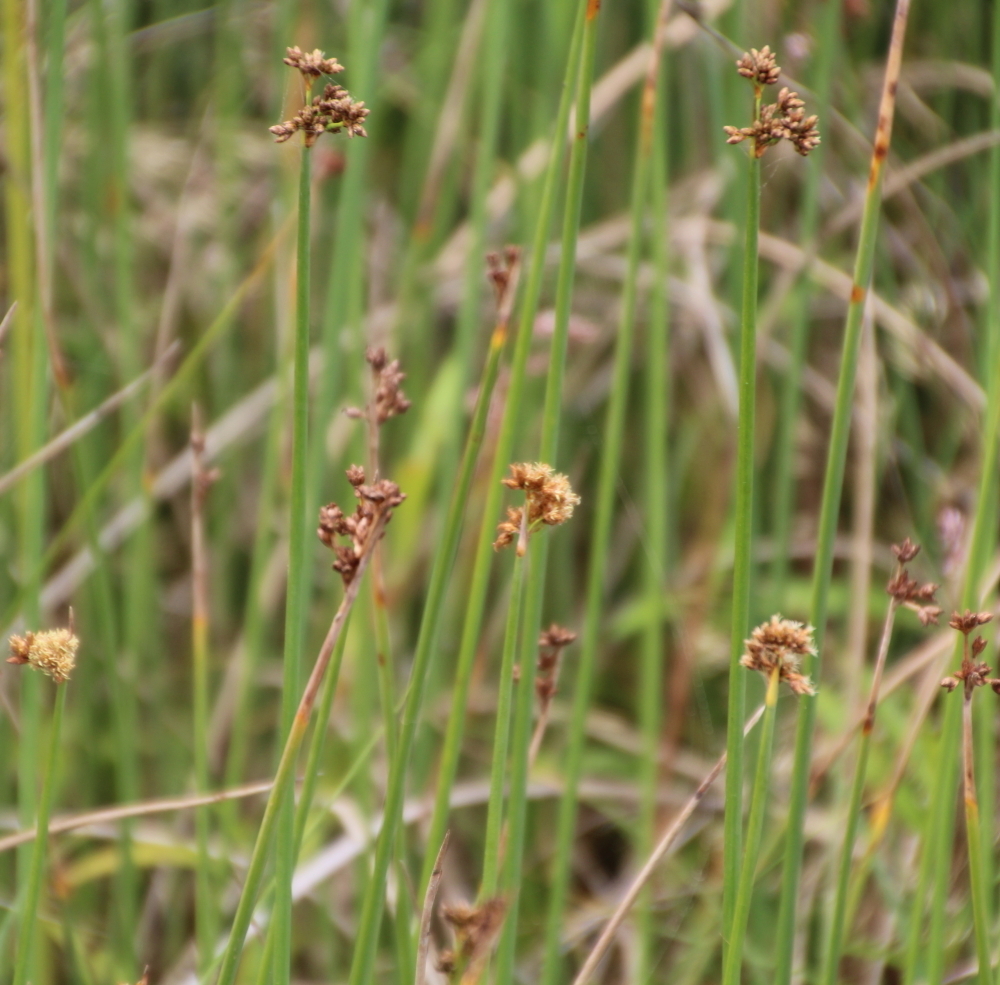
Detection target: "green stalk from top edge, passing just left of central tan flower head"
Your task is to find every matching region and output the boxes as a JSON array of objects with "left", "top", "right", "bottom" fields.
[{"left": 420, "top": 3, "right": 585, "bottom": 894}]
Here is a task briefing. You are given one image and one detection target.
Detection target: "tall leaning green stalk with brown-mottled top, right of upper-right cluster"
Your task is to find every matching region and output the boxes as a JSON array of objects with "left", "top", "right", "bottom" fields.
[{"left": 775, "top": 0, "right": 910, "bottom": 985}]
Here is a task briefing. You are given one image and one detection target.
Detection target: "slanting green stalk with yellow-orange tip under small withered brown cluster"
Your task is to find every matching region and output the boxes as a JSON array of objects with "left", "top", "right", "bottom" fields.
[{"left": 350, "top": 288, "right": 507, "bottom": 985}]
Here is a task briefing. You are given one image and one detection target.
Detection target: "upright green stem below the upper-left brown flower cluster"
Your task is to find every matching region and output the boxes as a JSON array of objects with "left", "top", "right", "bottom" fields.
[{"left": 273, "top": 136, "right": 312, "bottom": 985}]
